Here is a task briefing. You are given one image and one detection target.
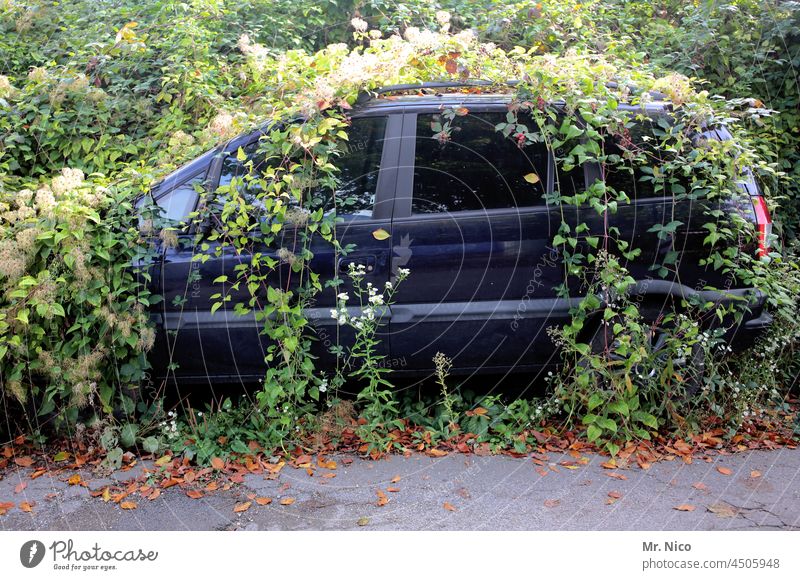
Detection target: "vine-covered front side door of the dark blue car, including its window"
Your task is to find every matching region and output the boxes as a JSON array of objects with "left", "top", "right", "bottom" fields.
[{"left": 150, "top": 115, "right": 401, "bottom": 381}]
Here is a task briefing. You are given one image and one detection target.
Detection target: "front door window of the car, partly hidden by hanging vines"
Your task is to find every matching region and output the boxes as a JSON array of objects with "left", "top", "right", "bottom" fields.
[{"left": 217, "top": 116, "right": 387, "bottom": 219}]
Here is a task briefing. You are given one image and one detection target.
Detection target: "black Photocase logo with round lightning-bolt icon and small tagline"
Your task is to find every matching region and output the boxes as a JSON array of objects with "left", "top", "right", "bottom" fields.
[{"left": 19, "top": 539, "right": 158, "bottom": 572}]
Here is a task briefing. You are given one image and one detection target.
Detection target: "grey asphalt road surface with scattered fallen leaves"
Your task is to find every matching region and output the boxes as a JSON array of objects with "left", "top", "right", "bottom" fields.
[{"left": 0, "top": 449, "right": 800, "bottom": 530}]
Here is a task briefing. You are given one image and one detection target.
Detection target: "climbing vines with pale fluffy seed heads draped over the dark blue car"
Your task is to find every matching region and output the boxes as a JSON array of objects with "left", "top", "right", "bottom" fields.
[{"left": 0, "top": 15, "right": 800, "bottom": 458}]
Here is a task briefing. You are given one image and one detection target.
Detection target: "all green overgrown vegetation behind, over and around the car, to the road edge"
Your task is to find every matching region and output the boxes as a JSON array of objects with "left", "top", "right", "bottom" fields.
[{"left": 0, "top": 0, "right": 800, "bottom": 462}]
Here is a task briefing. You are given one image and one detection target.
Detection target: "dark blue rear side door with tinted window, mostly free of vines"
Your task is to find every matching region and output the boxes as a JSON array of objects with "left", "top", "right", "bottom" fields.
[{"left": 391, "top": 104, "right": 569, "bottom": 370}]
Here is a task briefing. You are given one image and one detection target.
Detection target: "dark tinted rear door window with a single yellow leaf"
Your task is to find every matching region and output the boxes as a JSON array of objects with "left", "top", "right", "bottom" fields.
[{"left": 411, "top": 113, "right": 548, "bottom": 214}]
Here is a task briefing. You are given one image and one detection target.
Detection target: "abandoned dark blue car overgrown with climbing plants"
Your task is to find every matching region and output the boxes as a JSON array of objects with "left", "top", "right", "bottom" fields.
[{"left": 139, "top": 85, "right": 771, "bottom": 382}]
